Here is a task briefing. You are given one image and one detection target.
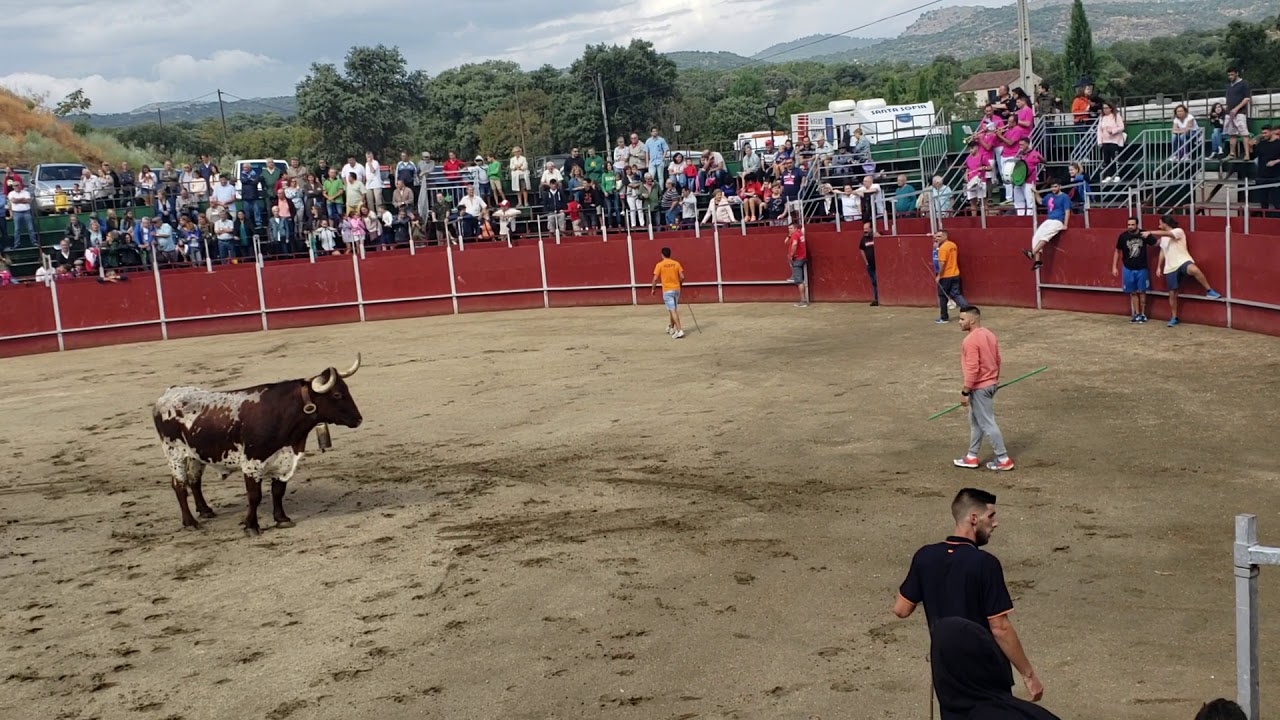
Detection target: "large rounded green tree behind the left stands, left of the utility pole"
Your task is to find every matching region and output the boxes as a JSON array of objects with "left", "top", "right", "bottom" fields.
[{"left": 297, "top": 45, "right": 426, "bottom": 158}]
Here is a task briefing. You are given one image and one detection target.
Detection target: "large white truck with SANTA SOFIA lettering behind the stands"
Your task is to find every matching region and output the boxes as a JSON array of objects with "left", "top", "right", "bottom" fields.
[{"left": 791, "top": 97, "right": 940, "bottom": 146}]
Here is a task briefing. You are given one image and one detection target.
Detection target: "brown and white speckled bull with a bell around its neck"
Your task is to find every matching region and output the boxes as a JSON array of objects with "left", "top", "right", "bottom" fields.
[{"left": 152, "top": 354, "right": 362, "bottom": 534}]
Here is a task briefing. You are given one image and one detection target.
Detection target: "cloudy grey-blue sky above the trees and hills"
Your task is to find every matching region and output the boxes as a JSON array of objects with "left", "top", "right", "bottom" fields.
[{"left": 0, "top": 0, "right": 1007, "bottom": 113}]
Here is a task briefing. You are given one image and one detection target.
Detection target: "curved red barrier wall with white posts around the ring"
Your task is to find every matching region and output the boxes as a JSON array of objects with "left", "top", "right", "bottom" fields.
[{"left": 0, "top": 221, "right": 1280, "bottom": 356}]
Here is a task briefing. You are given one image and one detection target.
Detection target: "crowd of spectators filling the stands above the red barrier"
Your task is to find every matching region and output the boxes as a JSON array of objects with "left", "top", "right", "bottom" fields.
[{"left": 0, "top": 68, "right": 1280, "bottom": 278}]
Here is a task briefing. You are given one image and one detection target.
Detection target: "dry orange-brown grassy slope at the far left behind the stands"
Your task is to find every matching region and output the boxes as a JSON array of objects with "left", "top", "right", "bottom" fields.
[{"left": 0, "top": 88, "right": 148, "bottom": 168}]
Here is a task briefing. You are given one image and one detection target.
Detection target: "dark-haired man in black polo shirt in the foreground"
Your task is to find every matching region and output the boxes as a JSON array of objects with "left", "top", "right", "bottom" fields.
[{"left": 893, "top": 488, "right": 1044, "bottom": 720}]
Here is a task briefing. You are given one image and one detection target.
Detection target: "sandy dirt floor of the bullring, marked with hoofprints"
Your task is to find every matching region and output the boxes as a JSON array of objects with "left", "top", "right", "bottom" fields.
[{"left": 0, "top": 305, "right": 1280, "bottom": 720}]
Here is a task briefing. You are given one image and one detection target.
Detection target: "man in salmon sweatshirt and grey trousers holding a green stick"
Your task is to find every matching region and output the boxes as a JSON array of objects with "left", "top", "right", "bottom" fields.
[{"left": 952, "top": 305, "right": 1014, "bottom": 470}]
